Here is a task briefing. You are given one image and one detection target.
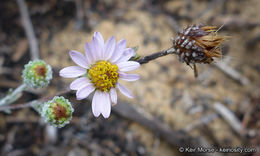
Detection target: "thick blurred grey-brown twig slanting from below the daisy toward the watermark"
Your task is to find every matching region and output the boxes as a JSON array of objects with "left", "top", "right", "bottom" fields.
[{"left": 113, "top": 101, "right": 215, "bottom": 155}]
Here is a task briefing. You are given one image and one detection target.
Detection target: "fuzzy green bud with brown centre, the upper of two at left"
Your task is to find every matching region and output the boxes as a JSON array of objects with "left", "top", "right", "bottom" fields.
[{"left": 22, "top": 60, "right": 52, "bottom": 88}]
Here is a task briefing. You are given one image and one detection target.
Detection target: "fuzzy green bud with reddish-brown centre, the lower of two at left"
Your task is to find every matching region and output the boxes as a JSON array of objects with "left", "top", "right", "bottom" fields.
[{"left": 41, "top": 96, "right": 74, "bottom": 128}]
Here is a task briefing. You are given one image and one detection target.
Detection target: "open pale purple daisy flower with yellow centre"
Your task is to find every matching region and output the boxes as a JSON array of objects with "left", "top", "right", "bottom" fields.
[{"left": 60, "top": 32, "right": 140, "bottom": 118}]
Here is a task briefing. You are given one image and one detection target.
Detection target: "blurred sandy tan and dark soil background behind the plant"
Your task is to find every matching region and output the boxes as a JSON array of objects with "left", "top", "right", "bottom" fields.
[{"left": 0, "top": 0, "right": 260, "bottom": 156}]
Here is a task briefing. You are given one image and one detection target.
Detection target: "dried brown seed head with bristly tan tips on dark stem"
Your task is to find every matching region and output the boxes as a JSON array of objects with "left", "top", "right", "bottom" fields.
[{"left": 173, "top": 24, "right": 225, "bottom": 65}]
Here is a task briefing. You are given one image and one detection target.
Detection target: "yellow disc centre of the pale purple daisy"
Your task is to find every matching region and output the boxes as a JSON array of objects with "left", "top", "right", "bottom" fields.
[{"left": 88, "top": 61, "right": 118, "bottom": 92}]
